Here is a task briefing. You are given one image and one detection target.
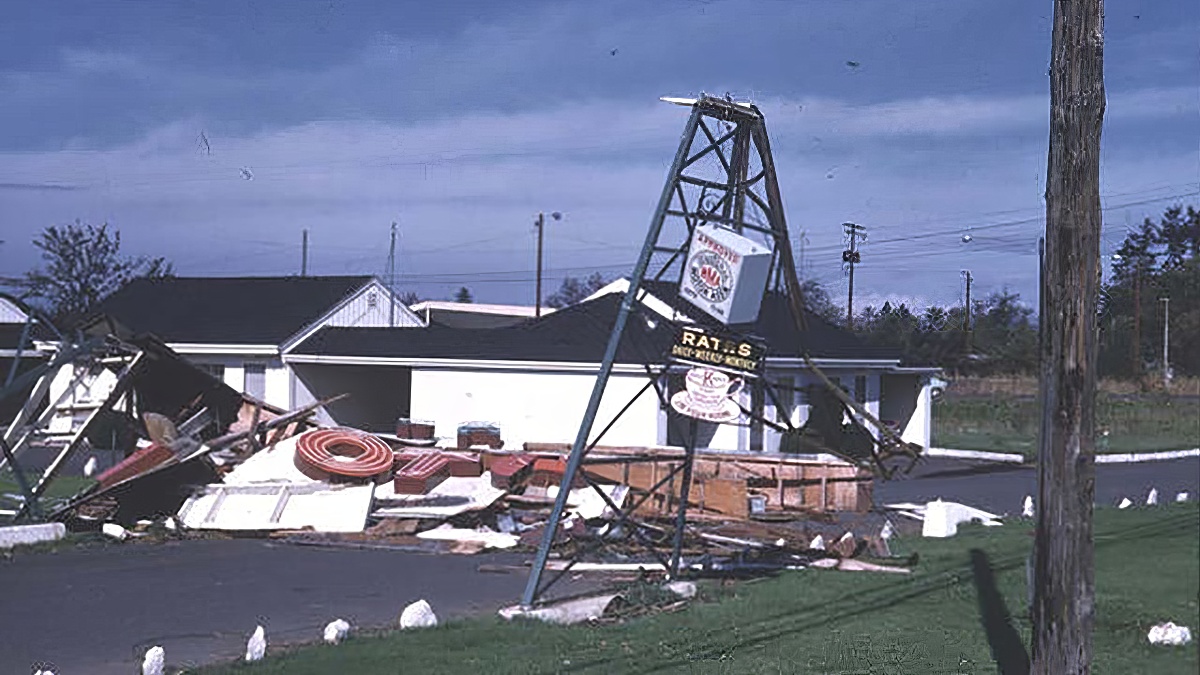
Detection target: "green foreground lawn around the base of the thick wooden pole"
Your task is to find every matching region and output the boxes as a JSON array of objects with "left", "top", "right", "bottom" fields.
[{"left": 199, "top": 502, "right": 1200, "bottom": 675}]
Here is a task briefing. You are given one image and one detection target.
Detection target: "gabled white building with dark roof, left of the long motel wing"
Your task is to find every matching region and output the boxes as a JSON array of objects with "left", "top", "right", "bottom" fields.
[{"left": 60, "top": 276, "right": 425, "bottom": 408}]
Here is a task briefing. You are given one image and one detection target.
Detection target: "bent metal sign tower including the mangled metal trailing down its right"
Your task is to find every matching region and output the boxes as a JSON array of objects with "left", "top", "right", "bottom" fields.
[{"left": 522, "top": 95, "right": 923, "bottom": 608}]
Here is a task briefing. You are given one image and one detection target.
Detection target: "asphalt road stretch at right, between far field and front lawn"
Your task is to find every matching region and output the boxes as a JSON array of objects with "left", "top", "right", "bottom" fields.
[{"left": 875, "top": 458, "right": 1200, "bottom": 514}]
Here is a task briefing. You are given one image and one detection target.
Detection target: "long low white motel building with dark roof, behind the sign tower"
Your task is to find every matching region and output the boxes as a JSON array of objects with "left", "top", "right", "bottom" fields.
[{"left": 290, "top": 276, "right": 937, "bottom": 450}]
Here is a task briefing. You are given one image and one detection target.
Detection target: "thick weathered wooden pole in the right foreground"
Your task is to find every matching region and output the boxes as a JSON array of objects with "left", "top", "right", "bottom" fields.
[{"left": 1031, "top": 0, "right": 1104, "bottom": 675}]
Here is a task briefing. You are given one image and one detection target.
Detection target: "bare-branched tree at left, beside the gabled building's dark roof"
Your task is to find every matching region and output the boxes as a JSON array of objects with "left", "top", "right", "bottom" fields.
[{"left": 16, "top": 220, "right": 174, "bottom": 325}]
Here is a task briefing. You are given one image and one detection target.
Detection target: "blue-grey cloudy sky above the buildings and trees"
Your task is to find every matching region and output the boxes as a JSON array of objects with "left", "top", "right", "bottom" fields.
[{"left": 0, "top": 0, "right": 1200, "bottom": 306}]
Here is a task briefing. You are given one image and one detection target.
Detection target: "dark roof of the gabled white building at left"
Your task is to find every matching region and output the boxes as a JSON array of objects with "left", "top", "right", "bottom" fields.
[{"left": 97, "top": 276, "right": 372, "bottom": 345}]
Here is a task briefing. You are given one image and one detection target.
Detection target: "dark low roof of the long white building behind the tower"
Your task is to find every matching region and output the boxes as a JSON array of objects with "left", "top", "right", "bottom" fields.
[{"left": 293, "top": 279, "right": 899, "bottom": 364}]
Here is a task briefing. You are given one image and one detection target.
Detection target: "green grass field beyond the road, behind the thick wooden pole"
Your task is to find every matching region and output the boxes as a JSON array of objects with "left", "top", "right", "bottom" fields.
[{"left": 934, "top": 394, "right": 1200, "bottom": 459}]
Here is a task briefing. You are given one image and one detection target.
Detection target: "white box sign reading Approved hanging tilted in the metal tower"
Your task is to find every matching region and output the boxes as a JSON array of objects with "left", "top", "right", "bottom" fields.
[{"left": 679, "top": 225, "right": 772, "bottom": 324}]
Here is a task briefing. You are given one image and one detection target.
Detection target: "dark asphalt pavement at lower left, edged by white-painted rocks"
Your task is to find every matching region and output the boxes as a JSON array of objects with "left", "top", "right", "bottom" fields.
[{"left": 0, "top": 539, "right": 556, "bottom": 675}]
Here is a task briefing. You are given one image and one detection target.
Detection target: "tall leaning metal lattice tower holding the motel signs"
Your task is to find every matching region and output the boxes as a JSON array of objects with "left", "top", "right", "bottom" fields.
[{"left": 522, "top": 95, "right": 916, "bottom": 608}]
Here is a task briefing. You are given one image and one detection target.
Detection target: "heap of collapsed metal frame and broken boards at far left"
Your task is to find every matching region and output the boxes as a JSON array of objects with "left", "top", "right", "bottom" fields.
[{"left": 0, "top": 313, "right": 330, "bottom": 522}]
